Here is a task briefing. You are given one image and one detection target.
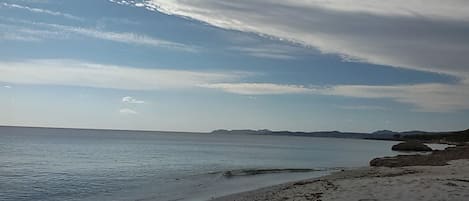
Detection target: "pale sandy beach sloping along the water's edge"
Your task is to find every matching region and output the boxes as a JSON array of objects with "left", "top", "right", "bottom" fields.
[{"left": 211, "top": 160, "right": 469, "bottom": 201}]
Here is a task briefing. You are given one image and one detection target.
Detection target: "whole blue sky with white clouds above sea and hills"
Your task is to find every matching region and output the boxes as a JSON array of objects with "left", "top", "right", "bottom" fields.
[{"left": 0, "top": 0, "right": 469, "bottom": 132}]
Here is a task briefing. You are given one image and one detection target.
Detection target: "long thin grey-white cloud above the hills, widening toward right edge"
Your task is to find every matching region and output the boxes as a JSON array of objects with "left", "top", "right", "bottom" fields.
[{"left": 201, "top": 83, "right": 469, "bottom": 112}]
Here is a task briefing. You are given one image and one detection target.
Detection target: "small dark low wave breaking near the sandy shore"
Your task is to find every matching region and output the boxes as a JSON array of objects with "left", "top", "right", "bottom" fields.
[{"left": 222, "top": 168, "right": 319, "bottom": 178}]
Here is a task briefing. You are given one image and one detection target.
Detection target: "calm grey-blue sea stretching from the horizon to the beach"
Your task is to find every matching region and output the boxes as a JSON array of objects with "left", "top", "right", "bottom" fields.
[{"left": 0, "top": 127, "right": 402, "bottom": 201}]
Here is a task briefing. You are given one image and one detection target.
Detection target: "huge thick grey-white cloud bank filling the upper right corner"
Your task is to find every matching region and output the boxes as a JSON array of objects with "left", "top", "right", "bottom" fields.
[{"left": 134, "top": 0, "right": 469, "bottom": 77}]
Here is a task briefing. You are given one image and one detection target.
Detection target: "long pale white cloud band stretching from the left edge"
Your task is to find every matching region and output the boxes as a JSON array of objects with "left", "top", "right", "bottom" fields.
[{"left": 0, "top": 60, "right": 241, "bottom": 90}]
